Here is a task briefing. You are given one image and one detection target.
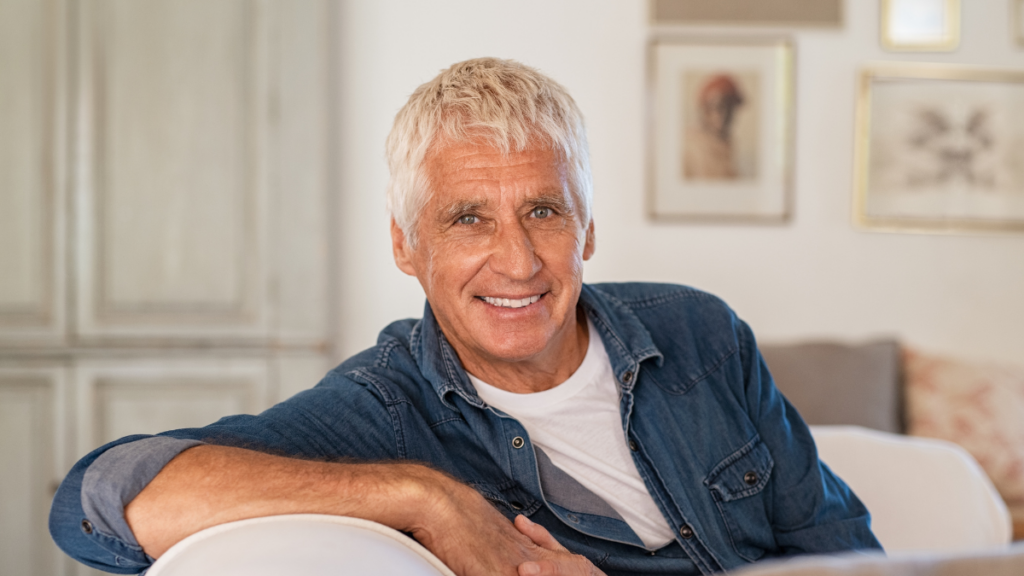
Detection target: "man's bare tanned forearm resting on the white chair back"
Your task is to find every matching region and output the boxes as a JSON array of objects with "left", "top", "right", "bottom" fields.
[{"left": 125, "top": 438, "right": 457, "bottom": 558}]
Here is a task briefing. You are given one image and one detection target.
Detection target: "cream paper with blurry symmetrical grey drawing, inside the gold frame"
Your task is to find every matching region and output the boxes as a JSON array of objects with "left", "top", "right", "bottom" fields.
[{"left": 864, "top": 79, "right": 1024, "bottom": 224}]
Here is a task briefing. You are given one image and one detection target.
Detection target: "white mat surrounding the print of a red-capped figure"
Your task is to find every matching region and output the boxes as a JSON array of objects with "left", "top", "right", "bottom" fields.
[{"left": 651, "top": 43, "right": 793, "bottom": 219}]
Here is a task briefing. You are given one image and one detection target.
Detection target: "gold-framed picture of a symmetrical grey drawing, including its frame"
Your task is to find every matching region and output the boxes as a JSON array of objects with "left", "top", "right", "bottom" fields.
[{"left": 854, "top": 65, "right": 1024, "bottom": 232}]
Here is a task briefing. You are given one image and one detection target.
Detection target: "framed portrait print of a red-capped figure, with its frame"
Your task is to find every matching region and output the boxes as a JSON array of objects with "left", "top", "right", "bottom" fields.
[{"left": 648, "top": 39, "right": 794, "bottom": 222}]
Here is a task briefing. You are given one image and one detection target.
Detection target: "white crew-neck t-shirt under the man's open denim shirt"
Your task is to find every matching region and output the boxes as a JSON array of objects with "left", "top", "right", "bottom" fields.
[{"left": 469, "top": 321, "right": 674, "bottom": 549}]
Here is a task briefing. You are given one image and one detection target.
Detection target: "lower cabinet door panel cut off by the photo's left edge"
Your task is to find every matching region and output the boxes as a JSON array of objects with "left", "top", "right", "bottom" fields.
[{"left": 0, "top": 371, "right": 58, "bottom": 576}]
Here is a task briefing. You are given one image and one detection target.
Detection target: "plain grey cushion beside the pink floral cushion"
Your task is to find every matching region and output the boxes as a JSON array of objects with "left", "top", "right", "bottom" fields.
[{"left": 760, "top": 340, "right": 903, "bottom": 434}]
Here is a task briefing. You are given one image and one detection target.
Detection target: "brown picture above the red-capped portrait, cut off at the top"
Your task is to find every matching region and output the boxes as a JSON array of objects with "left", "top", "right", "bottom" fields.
[{"left": 648, "top": 0, "right": 843, "bottom": 28}]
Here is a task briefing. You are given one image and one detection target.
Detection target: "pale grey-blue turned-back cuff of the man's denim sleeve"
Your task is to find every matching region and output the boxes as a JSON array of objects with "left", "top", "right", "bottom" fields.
[{"left": 82, "top": 436, "right": 204, "bottom": 546}]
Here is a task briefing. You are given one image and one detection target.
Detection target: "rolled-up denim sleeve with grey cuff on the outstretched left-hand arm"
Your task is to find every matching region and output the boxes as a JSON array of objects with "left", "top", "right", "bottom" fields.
[{"left": 49, "top": 372, "right": 399, "bottom": 574}]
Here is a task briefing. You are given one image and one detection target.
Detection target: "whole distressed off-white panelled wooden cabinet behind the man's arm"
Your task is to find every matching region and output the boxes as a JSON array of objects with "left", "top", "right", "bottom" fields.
[{"left": 0, "top": 0, "right": 335, "bottom": 576}]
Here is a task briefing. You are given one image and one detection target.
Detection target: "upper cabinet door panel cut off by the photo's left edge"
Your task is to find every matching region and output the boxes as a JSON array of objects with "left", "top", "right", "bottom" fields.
[{"left": 0, "top": 0, "right": 57, "bottom": 337}]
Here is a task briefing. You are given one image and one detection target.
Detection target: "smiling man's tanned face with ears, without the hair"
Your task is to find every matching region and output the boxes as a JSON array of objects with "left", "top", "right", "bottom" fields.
[{"left": 391, "top": 143, "right": 594, "bottom": 368}]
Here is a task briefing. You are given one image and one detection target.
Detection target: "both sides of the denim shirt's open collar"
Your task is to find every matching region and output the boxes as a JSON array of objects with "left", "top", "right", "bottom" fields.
[{"left": 410, "top": 284, "right": 664, "bottom": 408}]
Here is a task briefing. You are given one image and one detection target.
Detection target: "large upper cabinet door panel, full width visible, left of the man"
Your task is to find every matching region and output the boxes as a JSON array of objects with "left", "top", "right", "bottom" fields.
[{"left": 81, "top": 0, "right": 265, "bottom": 335}]
